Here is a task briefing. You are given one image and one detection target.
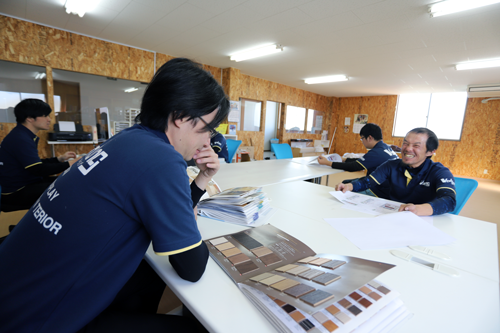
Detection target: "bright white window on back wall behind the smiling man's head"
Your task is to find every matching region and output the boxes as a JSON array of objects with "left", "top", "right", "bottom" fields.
[{"left": 393, "top": 92, "right": 467, "bottom": 140}]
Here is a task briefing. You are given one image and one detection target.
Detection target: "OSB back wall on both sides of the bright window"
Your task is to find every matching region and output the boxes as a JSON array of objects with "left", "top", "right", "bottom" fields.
[{"left": 331, "top": 96, "right": 500, "bottom": 180}]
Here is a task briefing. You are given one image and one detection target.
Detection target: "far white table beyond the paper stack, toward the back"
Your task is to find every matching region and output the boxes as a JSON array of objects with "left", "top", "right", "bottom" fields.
[{"left": 214, "top": 157, "right": 343, "bottom": 190}]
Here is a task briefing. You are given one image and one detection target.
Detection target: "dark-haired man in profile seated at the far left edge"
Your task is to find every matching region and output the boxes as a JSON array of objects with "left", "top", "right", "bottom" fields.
[{"left": 0, "top": 98, "right": 76, "bottom": 211}]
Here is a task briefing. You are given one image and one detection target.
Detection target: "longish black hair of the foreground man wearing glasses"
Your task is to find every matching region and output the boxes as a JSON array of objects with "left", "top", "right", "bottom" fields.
[{"left": 136, "top": 58, "right": 229, "bottom": 131}]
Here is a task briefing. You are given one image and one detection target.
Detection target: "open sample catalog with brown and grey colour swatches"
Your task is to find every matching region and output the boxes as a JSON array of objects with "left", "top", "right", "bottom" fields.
[{"left": 205, "top": 224, "right": 412, "bottom": 333}]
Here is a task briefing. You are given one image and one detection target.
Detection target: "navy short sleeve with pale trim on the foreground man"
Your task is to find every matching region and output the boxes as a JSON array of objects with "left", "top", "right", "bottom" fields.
[{"left": 124, "top": 156, "right": 201, "bottom": 255}]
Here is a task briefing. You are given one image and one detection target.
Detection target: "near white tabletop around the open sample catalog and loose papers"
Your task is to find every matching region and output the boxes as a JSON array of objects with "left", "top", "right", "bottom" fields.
[{"left": 147, "top": 182, "right": 500, "bottom": 332}]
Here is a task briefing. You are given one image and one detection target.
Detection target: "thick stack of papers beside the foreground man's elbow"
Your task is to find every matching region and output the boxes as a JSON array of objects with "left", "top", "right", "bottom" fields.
[{"left": 198, "top": 187, "right": 271, "bottom": 225}]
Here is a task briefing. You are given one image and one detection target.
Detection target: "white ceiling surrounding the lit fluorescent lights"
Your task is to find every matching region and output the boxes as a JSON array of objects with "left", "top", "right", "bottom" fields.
[{"left": 0, "top": 0, "right": 500, "bottom": 97}]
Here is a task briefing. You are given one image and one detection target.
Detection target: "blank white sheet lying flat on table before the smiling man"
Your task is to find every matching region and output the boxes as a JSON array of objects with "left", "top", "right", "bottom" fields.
[{"left": 324, "top": 212, "right": 456, "bottom": 250}]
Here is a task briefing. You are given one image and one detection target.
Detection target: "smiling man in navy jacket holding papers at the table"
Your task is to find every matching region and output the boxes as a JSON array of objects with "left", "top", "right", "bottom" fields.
[{"left": 335, "top": 127, "right": 456, "bottom": 216}]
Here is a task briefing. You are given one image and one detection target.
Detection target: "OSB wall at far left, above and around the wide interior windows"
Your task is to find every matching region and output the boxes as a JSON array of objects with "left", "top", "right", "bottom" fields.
[{"left": 0, "top": 15, "right": 156, "bottom": 158}]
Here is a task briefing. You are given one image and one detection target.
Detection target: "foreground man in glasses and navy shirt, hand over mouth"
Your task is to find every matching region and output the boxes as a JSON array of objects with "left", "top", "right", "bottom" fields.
[{"left": 0, "top": 58, "right": 229, "bottom": 333}]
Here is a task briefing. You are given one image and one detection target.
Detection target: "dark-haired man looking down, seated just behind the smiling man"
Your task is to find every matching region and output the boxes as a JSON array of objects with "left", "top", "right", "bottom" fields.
[{"left": 318, "top": 123, "right": 398, "bottom": 199}]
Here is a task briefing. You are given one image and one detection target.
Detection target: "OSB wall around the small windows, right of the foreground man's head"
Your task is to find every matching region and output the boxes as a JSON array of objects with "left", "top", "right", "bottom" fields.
[{"left": 222, "top": 68, "right": 336, "bottom": 160}]
